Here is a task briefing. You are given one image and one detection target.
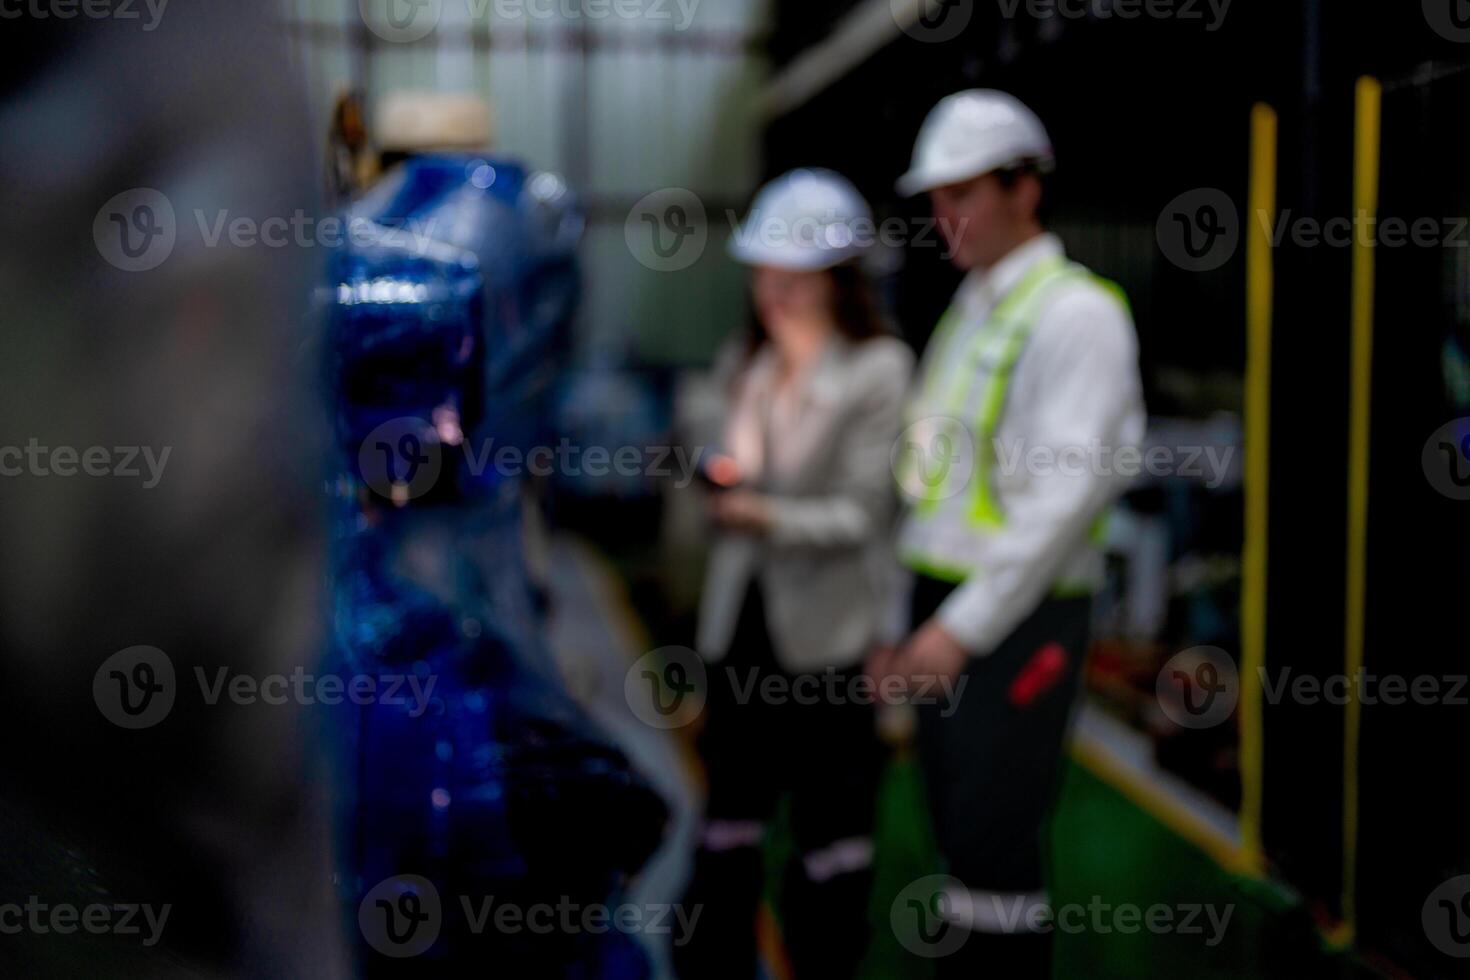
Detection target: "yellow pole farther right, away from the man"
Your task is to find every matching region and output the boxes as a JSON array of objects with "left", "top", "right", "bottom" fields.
[{"left": 1342, "top": 76, "right": 1383, "bottom": 940}]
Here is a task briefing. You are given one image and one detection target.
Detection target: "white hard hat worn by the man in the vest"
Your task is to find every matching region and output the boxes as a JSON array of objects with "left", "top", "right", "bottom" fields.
[{"left": 898, "top": 88, "right": 1053, "bottom": 195}]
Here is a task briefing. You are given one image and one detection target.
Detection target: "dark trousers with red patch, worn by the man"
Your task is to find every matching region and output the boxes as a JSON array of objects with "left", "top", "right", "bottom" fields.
[{"left": 911, "top": 577, "right": 1091, "bottom": 980}]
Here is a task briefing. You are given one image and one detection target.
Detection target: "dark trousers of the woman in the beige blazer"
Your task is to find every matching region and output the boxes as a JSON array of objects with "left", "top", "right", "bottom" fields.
[{"left": 675, "top": 586, "right": 883, "bottom": 980}]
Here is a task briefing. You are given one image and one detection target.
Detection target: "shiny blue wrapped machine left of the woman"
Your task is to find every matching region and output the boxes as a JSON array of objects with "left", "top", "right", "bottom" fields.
[{"left": 326, "top": 154, "right": 666, "bottom": 977}]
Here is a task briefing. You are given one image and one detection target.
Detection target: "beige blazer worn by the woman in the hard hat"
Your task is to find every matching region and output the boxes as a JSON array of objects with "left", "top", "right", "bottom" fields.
[{"left": 697, "top": 336, "right": 914, "bottom": 671}]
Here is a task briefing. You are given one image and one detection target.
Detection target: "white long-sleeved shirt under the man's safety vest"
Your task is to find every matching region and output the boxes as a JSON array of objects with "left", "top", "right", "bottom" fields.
[{"left": 901, "top": 235, "right": 1145, "bottom": 655}]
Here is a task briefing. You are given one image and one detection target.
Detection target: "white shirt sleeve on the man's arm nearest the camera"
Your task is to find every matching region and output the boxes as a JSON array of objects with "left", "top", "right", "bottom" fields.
[{"left": 936, "top": 284, "right": 1145, "bottom": 655}]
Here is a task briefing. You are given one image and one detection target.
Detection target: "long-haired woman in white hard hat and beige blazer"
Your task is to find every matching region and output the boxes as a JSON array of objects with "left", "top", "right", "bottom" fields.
[{"left": 679, "top": 170, "right": 913, "bottom": 980}]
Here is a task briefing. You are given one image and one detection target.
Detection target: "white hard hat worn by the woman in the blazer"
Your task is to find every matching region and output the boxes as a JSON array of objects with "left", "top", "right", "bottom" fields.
[{"left": 729, "top": 169, "right": 878, "bottom": 272}]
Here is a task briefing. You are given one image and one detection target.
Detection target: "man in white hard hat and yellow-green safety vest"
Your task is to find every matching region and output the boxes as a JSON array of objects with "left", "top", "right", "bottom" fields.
[{"left": 875, "top": 90, "right": 1144, "bottom": 979}]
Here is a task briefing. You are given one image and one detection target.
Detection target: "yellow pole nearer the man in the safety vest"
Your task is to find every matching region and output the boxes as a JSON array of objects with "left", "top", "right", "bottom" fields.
[{"left": 1241, "top": 103, "right": 1276, "bottom": 874}]
